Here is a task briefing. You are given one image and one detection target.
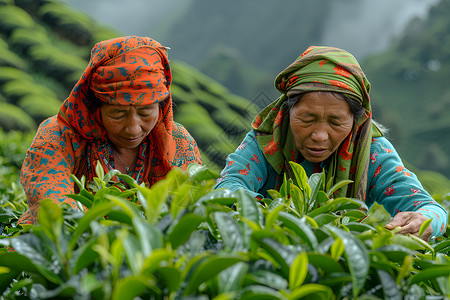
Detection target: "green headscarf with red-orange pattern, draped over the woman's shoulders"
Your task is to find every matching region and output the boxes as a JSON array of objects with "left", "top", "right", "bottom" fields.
[{"left": 252, "top": 46, "right": 382, "bottom": 200}]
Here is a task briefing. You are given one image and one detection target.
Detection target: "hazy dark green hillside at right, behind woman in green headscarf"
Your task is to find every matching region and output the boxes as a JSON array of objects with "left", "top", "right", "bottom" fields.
[{"left": 365, "top": 0, "right": 450, "bottom": 177}]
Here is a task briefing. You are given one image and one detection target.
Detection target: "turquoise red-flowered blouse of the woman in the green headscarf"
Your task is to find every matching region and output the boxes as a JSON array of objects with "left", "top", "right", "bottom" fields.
[{"left": 215, "top": 130, "right": 447, "bottom": 237}]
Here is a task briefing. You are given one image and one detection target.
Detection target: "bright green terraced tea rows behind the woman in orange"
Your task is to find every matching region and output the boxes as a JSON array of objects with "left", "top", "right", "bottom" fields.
[{"left": 0, "top": 0, "right": 257, "bottom": 169}]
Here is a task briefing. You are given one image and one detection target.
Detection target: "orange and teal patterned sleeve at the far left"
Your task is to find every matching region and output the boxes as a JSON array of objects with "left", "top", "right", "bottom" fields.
[{"left": 18, "top": 119, "right": 75, "bottom": 224}]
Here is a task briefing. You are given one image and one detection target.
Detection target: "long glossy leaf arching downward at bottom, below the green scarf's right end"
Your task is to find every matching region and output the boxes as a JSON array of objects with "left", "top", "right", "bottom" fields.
[{"left": 325, "top": 225, "right": 370, "bottom": 297}]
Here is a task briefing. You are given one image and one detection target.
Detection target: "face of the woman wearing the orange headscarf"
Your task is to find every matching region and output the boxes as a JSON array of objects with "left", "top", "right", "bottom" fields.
[{"left": 100, "top": 103, "right": 159, "bottom": 149}]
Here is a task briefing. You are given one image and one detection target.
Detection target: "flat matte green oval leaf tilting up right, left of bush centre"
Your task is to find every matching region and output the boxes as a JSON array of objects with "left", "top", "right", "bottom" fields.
[{"left": 168, "top": 213, "right": 204, "bottom": 249}]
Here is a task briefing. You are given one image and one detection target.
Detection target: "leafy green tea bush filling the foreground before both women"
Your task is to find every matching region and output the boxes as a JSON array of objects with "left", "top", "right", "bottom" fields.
[{"left": 0, "top": 165, "right": 450, "bottom": 299}]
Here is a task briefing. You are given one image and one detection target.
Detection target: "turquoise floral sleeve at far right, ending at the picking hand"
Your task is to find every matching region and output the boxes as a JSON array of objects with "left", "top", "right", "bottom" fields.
[{"left": 367, "top": 137, "right": 447, "bottom": 237}]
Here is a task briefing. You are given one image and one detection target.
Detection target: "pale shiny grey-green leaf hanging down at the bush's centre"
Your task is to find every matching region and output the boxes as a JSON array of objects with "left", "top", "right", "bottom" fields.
[{"left": 214, "top": 212, "right": 244, "bottom": 252}]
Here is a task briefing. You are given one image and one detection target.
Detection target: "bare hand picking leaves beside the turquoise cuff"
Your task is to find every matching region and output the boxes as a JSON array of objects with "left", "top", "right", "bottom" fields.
[{"left": 384, "top": 211, "right": 433, "bottom": 241}]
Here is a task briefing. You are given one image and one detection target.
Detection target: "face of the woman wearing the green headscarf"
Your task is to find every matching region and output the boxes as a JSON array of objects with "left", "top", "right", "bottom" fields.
[{"left": 290, "top": 92, "right": 353, "bottom": 163}]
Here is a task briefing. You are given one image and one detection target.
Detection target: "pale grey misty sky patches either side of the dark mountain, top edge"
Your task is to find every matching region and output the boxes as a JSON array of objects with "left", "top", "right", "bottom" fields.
[{"left": 64, "top": 0, "right": 439, "bottom": 58}]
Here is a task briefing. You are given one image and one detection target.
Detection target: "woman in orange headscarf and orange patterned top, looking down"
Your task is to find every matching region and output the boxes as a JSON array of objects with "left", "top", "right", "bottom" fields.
[{"left": 19, "top": 36, "right": 201, "bottom": 224}]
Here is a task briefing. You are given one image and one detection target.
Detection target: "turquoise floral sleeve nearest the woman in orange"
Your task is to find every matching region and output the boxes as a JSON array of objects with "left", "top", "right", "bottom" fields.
[{"left": 214, "top": 130, "right": 270, "bottom": 198}]
